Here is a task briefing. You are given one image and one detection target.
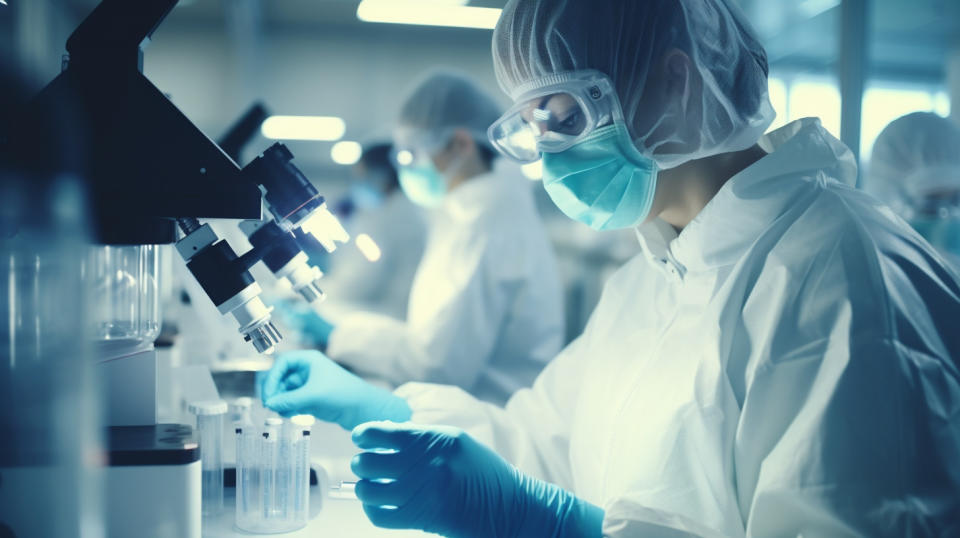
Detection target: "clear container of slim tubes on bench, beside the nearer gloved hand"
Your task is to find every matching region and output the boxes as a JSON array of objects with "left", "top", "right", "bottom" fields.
[{"left": 235, "top": 417, "right": 312, "bottom": 533}]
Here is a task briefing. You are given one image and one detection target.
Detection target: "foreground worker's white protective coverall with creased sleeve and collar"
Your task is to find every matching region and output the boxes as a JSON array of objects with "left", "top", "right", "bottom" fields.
[{"left": 397, "top": 119, "right": 960, "bottom": 537}]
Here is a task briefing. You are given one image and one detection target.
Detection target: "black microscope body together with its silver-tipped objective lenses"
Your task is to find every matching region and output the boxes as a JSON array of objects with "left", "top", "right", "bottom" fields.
[{"left": 4, "top": 0, "right": 347, "bottom": 358}]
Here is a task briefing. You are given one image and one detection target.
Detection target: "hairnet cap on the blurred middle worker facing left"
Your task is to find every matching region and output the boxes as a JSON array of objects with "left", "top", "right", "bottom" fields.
[{"left": 396, "top": 71, "right": 503, "bottom": 149}]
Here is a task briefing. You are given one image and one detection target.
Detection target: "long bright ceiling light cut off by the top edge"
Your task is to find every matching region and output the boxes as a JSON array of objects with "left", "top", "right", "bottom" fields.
[{"left": 357, "top": 0, "right": 503, "bottom": 30}]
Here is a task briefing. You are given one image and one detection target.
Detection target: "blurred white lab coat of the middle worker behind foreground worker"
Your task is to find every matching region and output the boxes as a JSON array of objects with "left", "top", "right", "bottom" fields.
[{"left": 327, "top": 163, "right": 563, "bottom": 403}]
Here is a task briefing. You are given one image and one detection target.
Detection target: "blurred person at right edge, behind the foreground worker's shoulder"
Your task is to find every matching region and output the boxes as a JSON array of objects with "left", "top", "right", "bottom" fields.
[{"left": 865, "top": 112, "right": 960, "bottom": 268}]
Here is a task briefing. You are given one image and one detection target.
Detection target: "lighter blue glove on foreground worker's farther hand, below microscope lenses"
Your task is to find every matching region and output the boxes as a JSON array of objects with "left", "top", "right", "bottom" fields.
[{"left": 260, "top": 350, "right": 411, "bottom": 430}]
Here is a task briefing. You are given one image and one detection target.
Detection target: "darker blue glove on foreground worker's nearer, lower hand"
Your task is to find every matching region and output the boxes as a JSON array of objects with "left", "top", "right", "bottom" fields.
[{"left": 350, "top": 422, "right": 603, "bottom": 538}]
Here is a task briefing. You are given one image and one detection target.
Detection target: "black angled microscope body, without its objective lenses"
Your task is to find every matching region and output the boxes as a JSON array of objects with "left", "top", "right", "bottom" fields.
[{"left": 8, "top": 0, "right": 261, "bottom": 245}]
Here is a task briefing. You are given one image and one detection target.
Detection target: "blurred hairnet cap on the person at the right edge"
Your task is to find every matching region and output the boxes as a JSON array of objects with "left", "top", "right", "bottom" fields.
[{"left": 864, "top": 112, "right": 960, "bottom": 212}]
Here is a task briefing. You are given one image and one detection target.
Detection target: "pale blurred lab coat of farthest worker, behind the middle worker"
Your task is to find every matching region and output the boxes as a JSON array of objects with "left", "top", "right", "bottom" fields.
[{"left": 318, "top": 189, "right": 427, "bottom": 324}]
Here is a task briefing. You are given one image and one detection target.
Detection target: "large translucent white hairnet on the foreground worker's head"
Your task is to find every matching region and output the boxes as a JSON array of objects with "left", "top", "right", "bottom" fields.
[{"left": 493, "top": 0, "right": 775, "bottom": 168}]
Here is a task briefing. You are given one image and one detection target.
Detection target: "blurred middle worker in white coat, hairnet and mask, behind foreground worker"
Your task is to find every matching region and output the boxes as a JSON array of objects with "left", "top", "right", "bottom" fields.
[{"left": 284, "top": 72, "right": 563, "bottom": 404}]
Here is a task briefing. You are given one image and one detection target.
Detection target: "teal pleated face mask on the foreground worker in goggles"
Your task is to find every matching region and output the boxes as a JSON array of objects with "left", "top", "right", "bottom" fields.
[{"left": 543, "top": 123, "right": 657, "bottom": 230}]
